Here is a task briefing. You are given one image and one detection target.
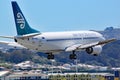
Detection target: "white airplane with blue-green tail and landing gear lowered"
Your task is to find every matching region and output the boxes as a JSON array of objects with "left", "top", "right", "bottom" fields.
[{"left": 0, "top": 1, "right": 116, "bottom": 59}]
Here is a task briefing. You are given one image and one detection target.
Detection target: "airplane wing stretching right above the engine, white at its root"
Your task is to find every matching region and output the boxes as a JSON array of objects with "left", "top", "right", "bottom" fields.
[{"left": 65, "top": 39, "right": 116, "bottom": 51}]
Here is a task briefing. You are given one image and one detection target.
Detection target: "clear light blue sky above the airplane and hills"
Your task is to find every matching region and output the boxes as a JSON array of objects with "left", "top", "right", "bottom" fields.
[{"left": 0, "top": 0, "right": 120, "bottom": 36}]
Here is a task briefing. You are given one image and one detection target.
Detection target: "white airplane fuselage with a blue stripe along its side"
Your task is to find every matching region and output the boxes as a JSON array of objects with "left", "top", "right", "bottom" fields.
[{"left": 17, "top": 31, "right": 105, "bottom": 52}]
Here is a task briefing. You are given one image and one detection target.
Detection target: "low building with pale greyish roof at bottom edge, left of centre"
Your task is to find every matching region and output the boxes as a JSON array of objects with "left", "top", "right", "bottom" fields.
[{"left": 6, "top": 71, "right": 49, "bottom": 80}]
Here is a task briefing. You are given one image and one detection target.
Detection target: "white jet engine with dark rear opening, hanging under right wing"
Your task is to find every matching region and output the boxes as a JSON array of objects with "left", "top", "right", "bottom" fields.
[{"left": 86, "top": 45, "right": 102, "bottom": 56}]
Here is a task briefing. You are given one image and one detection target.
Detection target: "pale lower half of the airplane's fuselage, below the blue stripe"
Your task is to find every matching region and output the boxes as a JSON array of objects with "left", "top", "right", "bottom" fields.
[{"left": 18, "top": 35, "right": 102, "bottom": 52}]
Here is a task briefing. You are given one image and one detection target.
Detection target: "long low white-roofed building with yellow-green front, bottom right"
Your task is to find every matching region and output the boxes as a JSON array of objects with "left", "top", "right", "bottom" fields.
[{"left": 49, "top": 73, "right": 114, "bottom": 80}]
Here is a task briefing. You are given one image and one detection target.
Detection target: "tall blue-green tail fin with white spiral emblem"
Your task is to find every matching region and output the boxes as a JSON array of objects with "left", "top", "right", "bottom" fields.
[{"left": 12, "top": 1, "right": 39, "bottom": 35}]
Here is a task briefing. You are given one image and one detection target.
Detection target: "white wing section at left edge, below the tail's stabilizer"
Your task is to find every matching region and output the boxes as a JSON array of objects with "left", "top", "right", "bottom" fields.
[{"left": 0, "top": 41, "right": 25, "bottom": 49}]
